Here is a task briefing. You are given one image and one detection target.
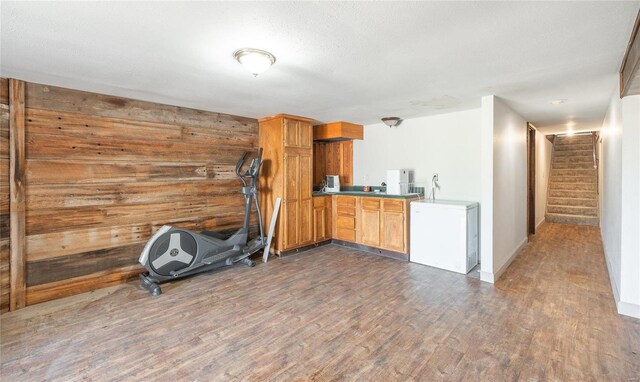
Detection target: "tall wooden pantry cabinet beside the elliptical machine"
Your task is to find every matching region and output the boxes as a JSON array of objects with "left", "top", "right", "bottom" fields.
[{"left": 258, "top": 114, "right": 314, "bottom": 254}]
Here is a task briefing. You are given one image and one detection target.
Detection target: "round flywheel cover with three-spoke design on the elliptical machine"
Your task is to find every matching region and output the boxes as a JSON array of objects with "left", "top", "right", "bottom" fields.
[{"left": 148, "top": 230, "right": 198, "bottom": 276}]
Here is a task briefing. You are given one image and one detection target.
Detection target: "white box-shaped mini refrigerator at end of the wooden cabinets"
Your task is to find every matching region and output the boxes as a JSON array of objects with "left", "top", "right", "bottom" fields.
[{"left": 409, "top": 200, "right": 479, "bottom": 274}]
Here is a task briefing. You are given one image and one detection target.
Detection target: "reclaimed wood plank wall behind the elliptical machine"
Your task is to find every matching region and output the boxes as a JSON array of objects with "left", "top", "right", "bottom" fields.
[{"left": 0, "top": 80, "right": 258, "bottom": 310}]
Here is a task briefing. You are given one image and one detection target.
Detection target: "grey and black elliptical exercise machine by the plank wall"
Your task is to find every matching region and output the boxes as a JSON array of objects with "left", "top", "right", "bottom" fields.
[{"left": 138, "top": 149, "right": 266, "bottom": 296}]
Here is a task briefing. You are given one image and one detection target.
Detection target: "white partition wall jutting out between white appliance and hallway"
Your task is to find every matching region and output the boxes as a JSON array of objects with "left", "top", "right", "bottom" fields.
[{"left": 481, "top": 96, "right": 527, "bottom": 282}]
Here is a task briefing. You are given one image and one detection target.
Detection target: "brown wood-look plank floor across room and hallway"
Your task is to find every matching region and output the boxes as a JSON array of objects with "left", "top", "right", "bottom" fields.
[{"left": 0, "top": 223, "right": 640, "bottom": 381}]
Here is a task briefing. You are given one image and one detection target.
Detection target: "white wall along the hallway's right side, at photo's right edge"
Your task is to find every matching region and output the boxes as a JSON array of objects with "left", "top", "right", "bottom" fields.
[{"left": 600, "top": 82, "right": 640, "bottom": 318}]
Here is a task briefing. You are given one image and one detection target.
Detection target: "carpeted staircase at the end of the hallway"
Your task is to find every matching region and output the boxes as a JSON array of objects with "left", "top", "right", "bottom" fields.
[{"left": 546, "top": 134, "right": 600, "bottom": 226}]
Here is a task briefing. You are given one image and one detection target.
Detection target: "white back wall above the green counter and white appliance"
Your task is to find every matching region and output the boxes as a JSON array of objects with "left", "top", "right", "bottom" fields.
[{"left": 353, "top": 109, "right": 481, "bottom": 202}]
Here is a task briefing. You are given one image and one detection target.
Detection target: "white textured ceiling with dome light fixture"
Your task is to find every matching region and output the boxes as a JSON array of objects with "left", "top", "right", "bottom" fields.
[{"left": 0, "top": 1, "right": 640, "bottom": 132}]
